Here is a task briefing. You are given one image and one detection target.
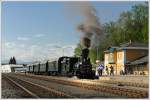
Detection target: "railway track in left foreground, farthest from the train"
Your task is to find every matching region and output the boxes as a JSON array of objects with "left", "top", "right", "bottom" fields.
[{"left": 4, "top": 75, "right": 75, "bottom": 98}]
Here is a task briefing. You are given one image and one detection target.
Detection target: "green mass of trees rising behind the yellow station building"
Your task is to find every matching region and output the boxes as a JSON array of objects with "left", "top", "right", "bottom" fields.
[{"left": 101, "top": 3, "right": 148, "bottom": 49}]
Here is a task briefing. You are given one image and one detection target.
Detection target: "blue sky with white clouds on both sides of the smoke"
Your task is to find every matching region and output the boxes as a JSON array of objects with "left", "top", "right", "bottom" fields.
[{"left": 1, "top": 1, "right": 143, "bottom": 63}]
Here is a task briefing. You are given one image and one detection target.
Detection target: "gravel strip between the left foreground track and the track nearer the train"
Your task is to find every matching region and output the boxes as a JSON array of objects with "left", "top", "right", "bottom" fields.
[{"left": 11, "top": 75, "right": 125, "bottom": 98}]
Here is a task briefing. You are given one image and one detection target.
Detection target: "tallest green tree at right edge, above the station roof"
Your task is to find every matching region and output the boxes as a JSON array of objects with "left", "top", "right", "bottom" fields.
[{"left": 117, "top": 3, "right": 148, "bottom": 43}]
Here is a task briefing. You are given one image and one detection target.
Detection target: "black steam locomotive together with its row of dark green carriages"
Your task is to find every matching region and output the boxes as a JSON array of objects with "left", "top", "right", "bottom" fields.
[{"left": 27, "top": 48, "right": 95, "bottom": 79}]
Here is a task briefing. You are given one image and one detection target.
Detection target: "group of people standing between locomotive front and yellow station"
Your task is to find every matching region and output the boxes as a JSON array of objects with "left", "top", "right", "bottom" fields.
[{"left": 97, "top": 64, "right": 114, "bottom": 76}]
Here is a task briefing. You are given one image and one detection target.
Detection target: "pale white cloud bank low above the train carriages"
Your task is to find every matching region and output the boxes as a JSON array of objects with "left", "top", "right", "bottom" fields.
[{"left": 2, "top": 42, "right": 75, "bottom": 62}]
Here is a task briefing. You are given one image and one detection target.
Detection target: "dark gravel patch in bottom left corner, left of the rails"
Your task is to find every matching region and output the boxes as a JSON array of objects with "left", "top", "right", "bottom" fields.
[{"left": 1, "top": 76, "right": 29, "bottom": 99}]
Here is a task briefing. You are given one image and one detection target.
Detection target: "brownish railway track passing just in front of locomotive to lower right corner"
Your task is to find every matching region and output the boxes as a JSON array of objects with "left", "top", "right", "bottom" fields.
[{"left": 15, "top": 74, "right": 148, "bottom": 98}]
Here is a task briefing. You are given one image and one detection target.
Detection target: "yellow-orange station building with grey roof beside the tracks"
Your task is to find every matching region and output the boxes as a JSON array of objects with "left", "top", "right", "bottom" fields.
[{"left": 104, "top": 42, "right": 148, "bottom": 75}]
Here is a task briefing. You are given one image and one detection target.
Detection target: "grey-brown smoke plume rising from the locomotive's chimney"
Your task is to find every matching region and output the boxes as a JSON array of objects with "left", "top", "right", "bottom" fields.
[{"left": 65, "top": 2, "right": 103, "bottom": 48}]
